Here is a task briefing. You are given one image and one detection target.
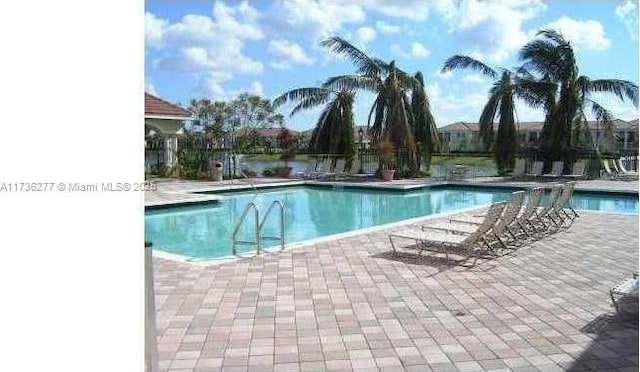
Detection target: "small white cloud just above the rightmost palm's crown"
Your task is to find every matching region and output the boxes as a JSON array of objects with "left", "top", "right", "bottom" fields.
[{"left": 541, "top": 16, "right": 611, "bottom": 50}]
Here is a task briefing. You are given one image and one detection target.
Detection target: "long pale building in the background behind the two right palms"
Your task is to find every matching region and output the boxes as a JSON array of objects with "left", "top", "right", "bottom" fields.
[{"left": 438, "top": 119, "right": 638, "bottom": 152}]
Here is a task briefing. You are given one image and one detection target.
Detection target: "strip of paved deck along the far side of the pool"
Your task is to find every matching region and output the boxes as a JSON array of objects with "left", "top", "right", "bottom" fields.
[{"left": 145, "top": 177, "right": 638, "bottom": 207}]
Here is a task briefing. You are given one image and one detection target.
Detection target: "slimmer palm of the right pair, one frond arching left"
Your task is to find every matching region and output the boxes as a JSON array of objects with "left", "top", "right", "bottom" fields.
[{"left": 442, "top": 55, "right": 519, "bottom": 174}]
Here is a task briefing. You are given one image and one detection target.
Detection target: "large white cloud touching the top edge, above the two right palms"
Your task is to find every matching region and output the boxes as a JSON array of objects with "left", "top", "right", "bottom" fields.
[{"left": 440, "top": 0, "right": 546, "bottom": 62}]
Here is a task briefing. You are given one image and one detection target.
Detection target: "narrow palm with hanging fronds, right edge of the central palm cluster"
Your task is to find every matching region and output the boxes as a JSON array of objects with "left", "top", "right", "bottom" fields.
[{"left": 411, "top": 71, "right": 440, "bottom": 171}]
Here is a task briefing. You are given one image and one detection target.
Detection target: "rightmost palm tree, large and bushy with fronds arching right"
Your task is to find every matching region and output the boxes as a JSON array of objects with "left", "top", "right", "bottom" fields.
[{"left": 520, "top": 29, "right": 638, "bottom": 161}]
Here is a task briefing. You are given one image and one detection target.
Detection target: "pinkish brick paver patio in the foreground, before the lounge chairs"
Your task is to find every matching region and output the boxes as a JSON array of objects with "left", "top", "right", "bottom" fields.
[{"left": 154, "top": 213, "right": 638, "bottom": 371}]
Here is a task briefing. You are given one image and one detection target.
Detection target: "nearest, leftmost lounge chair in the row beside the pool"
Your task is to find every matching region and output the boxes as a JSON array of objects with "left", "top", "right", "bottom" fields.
[{"left": 389, "top": 202, "right": 506, "bottom": 264}]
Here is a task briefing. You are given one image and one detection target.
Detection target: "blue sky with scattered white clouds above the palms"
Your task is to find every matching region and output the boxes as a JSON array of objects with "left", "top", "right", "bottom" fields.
[{"left": 145, "top": 0, "right": 638, "bottom": 130}]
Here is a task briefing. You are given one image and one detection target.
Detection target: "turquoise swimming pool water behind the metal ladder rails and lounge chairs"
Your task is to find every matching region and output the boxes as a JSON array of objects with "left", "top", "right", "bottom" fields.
[{"left": 145, "top": 186, "right": 638, "bottom": 259}]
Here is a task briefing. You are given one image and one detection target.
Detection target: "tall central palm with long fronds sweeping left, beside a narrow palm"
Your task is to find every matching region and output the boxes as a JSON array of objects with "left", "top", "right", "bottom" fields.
[{"left": 321, "top": 36, "right": 421, "bottom": 171}]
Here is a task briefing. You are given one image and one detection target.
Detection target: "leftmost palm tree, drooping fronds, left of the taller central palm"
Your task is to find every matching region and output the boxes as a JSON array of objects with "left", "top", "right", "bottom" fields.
[{"left": 273, "top": 86, "right": 355, "bottom": 159}]
